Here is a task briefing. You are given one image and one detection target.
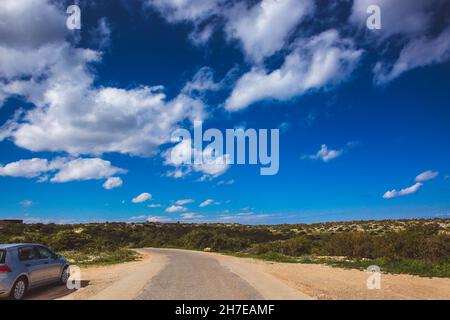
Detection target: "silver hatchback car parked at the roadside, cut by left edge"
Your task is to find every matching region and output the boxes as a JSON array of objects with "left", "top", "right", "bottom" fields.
[{"left": 0, "top": 244, "right": 70, "bottom": 300}]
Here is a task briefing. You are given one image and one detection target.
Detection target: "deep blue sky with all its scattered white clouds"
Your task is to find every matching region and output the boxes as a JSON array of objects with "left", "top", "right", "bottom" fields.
[{"left": 0, "top": 0, "right": 450, "bottom": 224}]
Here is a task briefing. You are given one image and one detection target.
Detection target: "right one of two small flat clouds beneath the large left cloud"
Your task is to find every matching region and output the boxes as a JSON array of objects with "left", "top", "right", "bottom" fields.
[{"left": 50, "top": 158, "right": 126, "bottom": 182}]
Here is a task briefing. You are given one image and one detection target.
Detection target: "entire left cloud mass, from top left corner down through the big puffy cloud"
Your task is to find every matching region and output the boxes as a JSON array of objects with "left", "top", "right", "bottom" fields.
[{"left": 0, "top": 0, "right": 205, "bottom": 156}]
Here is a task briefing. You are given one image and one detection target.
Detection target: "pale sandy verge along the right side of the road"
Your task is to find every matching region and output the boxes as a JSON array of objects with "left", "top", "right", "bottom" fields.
[{"left": 210, "top": 253, "right": 450, "bottom": 300}]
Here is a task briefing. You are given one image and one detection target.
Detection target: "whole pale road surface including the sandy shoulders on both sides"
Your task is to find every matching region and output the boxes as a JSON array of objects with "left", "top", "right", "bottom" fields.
[{"left": 28, "top": 249, "right": 450, "bottom": 300}]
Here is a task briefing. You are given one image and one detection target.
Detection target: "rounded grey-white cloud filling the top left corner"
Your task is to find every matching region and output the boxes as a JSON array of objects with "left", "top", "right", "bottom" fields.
[{"left": 0, "top": 0, "right": 67, "bottom": 80}]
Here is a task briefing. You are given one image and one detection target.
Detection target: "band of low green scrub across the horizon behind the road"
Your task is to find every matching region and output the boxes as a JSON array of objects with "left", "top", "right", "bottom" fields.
[{"left": 0, "top": 219, "right": 450, "bottom": 277}]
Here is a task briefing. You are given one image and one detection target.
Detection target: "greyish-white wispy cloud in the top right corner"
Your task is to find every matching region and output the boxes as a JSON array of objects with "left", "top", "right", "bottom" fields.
[{"left": 350, "top": 0, "right": 450, "bottom": 84}]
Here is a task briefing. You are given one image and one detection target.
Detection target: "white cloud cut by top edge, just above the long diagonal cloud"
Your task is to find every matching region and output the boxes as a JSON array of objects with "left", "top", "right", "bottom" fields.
[{"left": 147, "top": 0, "right": 314, "bottom": 63}]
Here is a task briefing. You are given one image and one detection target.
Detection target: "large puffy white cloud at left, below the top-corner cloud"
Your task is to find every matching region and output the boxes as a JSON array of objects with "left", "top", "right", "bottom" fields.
[{"left": 4, "top": 83, "right": 203, "bottom": 155}]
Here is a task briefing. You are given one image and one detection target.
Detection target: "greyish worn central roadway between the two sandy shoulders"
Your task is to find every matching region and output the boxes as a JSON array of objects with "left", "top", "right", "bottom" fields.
[{"left": 138, "top": 249, "right": 309, "bottom": 300}]
